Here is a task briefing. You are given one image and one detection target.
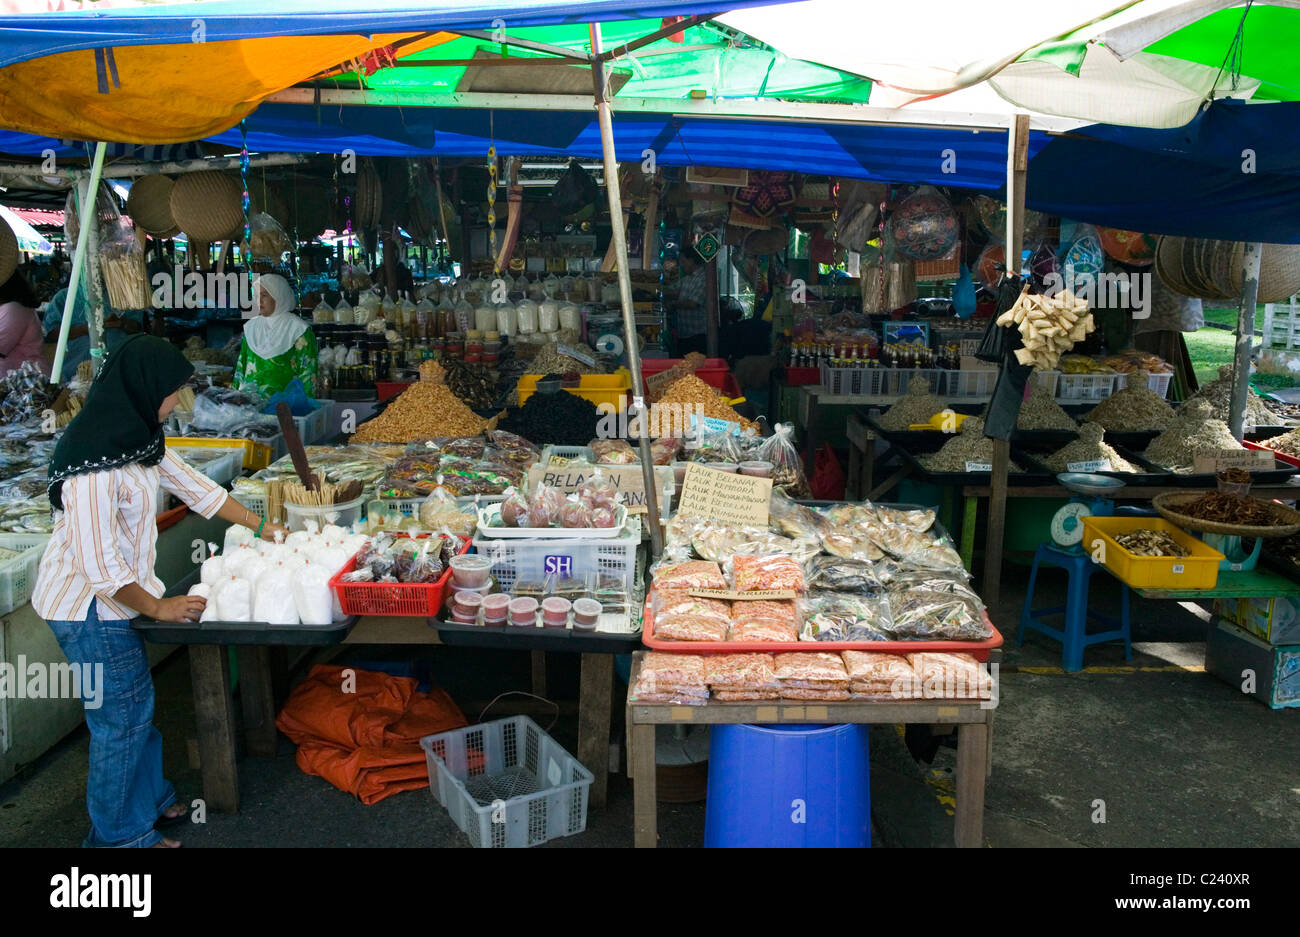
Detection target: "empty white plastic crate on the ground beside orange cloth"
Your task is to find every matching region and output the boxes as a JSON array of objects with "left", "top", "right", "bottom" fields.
[{"left": 420, "top": 716, "right": 593, "bottom": 849}]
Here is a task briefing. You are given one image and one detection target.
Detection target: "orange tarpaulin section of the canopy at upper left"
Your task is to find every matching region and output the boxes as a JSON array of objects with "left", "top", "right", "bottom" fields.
[{"left": 0, "top": 32, "right": 458, "bottom": 143}]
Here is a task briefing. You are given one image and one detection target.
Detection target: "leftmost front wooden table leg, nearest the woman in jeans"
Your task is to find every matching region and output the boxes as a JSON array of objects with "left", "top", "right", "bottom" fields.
[{"left": 190, "top": 645, "right": 239, "bottom": 814}]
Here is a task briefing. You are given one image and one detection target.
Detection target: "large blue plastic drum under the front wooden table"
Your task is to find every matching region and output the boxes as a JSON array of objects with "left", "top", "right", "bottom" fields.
[{"left": 705, "top": 725, "right": 871, "bottom": 849}]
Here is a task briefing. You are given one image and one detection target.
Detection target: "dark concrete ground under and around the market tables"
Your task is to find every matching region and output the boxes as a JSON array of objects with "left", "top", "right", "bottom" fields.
[{"left": 0, "top": 567, "right": 1300, "bottom": 847}]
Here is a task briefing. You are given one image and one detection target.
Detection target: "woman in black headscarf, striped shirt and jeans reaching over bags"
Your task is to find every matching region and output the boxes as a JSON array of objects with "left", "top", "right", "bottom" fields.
[{"left": 31, "top": 335, "right": 282, "bottom": 846}]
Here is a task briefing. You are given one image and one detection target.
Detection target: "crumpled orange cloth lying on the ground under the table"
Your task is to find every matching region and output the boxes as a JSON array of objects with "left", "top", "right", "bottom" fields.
[{"left": 276, "top": 667, "right": 468, "bottom": 804}]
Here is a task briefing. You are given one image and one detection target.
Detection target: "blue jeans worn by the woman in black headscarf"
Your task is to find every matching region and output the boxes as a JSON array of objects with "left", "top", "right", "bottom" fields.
[{"left": 49, "top": 602, "right": 176, "bottom": 847}]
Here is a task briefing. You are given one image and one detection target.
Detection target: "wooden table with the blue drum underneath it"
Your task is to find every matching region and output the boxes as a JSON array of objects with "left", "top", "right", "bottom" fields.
[{"left": 628, "top": 651, "right": 996, "bottom": 849}]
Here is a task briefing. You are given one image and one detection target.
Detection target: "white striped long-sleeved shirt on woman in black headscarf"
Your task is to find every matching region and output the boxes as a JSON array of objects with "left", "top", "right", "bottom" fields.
[{"left": 31, "top": 451, "right": 226, "bottom": 621}]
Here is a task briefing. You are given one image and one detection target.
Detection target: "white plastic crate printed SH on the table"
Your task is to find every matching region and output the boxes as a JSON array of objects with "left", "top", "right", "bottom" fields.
[{"left": 473, "top": 515, "right": 641, "bottom": 594}]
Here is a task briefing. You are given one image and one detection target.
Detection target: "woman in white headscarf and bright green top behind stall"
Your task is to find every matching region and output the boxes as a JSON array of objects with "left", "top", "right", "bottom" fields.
[{"left": 234, "top": 273, "right": 317, "bottom": 396}]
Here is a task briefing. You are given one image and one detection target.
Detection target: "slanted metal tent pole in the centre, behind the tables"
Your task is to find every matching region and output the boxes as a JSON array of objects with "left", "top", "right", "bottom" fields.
[{"left": 589, "top": 23, "right": 663, "bottom": 558}]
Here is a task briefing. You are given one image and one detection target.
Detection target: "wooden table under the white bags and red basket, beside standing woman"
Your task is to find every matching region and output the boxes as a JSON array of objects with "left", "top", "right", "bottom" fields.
[{"left": 137, "top": 613, "right": 629, "bottom": 814}]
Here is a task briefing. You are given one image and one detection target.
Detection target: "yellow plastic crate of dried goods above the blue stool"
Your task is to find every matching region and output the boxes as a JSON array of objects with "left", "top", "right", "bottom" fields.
[{"left": 1083, "top": 517, "right": 1225, "bottom": 590}]
